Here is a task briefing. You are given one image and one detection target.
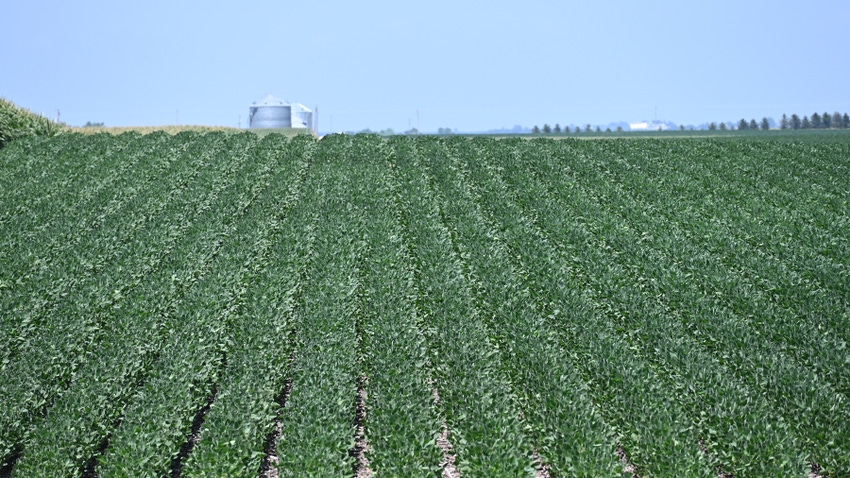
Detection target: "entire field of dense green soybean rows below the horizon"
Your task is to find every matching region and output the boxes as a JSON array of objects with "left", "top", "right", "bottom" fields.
[{"left": 0, "top": 132, "right": 850, "bottom": 477}]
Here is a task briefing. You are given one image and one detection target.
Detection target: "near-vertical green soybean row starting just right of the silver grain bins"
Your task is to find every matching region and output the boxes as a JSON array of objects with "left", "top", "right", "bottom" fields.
[{"left": 268, "top": 133, "right": 365, "bottom": 476}]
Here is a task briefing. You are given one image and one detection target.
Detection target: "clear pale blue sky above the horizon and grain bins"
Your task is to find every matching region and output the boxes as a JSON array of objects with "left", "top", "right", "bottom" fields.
[{"left": 0, "top": 0, "right": 850, "bottom": 131}]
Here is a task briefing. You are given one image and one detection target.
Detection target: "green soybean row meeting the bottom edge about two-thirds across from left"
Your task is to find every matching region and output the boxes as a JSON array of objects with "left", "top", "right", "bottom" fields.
[{"left": 400, "top": 136, "right": 621, "bottom": 476}]
